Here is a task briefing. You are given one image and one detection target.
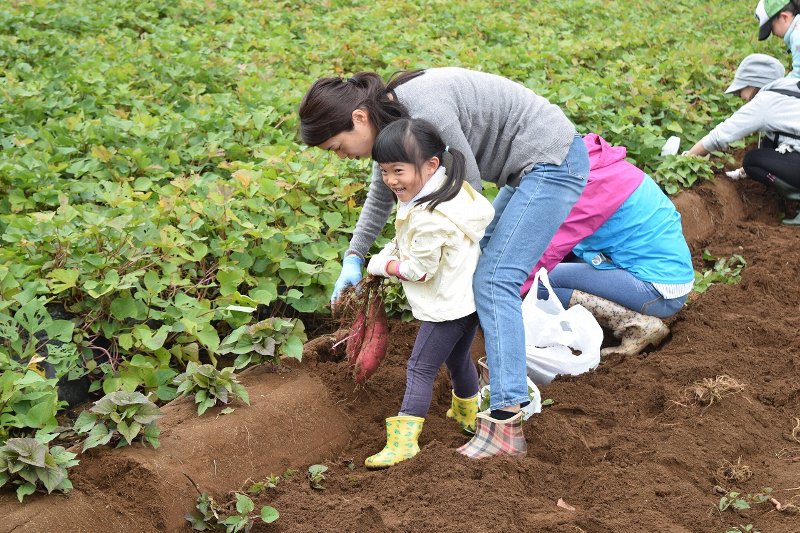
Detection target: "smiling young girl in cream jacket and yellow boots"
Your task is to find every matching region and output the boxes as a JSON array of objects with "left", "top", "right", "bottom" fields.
[{"left": 365, "top": 119, "right": 494, "bottom": 468}]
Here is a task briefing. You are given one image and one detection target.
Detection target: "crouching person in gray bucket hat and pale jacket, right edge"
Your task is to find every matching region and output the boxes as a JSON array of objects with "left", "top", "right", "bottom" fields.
[{"left": 684, "top": 54, "right": 800, "bottom": 212}]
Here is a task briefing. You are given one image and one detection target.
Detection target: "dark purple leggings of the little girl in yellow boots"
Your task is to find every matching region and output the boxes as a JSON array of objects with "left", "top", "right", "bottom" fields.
[{"left": 400, "top": 313, "right": 478, "bottom": 418}]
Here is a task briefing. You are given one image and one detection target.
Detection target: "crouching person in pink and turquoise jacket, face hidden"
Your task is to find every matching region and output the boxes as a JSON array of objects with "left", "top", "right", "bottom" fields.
[{"left": 521, "top": 133, "right": 694, "bottom": 356}]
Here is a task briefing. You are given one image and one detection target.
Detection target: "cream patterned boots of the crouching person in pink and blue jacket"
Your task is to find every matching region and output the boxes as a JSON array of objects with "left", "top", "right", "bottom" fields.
[{"left": 569, "top": 290, "right": 669, "bottom": 357}]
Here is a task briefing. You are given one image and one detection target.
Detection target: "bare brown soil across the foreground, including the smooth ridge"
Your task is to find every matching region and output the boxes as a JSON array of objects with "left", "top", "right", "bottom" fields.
[{"left": 0, "top": 177, "right": 800, "bottom": 533}]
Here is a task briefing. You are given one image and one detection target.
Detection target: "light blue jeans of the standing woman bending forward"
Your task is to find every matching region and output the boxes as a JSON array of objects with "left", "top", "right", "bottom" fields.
[{"left": 473, "top": 135, "right": 589, "bottom": 409}]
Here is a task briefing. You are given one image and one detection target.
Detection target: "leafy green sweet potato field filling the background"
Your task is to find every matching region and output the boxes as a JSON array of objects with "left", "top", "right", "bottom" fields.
[{"left": 0, "top": 0, "right": 783, "bottom": 441}]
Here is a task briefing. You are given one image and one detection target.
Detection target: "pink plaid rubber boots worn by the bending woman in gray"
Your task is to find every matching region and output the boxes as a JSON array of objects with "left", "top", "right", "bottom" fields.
[{"left": 458, "top": 411, "right": 528, "bottom": 459}]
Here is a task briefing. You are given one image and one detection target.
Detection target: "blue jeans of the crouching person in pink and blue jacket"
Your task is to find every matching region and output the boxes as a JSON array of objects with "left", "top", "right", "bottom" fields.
[{"left": 539, "top": 262, "right": 688, "bottom": 318}]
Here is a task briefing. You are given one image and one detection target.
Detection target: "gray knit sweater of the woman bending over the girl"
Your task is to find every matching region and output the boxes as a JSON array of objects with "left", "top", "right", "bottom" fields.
[{"left": 346, "top": 67, "right": 576, "bottom": 257}]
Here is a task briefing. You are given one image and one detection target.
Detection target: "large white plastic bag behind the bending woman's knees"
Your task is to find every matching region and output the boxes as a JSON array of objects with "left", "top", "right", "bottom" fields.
[{"left": 522, "top": 268, "right": 603, "bottom": 385}]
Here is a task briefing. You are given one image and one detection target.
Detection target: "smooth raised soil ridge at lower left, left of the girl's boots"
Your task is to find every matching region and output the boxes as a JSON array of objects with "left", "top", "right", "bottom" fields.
[{"left": 0, "top": 368, "right": 348, "bottom": 533}]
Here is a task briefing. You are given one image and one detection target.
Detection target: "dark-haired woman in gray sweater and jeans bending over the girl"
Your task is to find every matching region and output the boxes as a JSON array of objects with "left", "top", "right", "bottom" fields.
[{"left": 299, "top": 67, "right": 589, "bottom": 458}]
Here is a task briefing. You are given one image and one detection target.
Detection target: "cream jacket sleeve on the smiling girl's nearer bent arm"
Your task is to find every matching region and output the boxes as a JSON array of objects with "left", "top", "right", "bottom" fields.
[{"left": 398, "top": 211, "right": 454, "bottom": 282}]
